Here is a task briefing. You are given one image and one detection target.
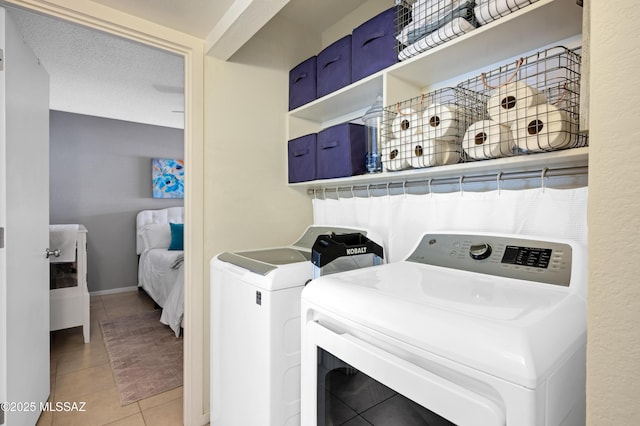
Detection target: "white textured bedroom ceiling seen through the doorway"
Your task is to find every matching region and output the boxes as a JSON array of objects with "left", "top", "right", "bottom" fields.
[{"left": 9, "top": 8, "right": 184, "bottom": 128}]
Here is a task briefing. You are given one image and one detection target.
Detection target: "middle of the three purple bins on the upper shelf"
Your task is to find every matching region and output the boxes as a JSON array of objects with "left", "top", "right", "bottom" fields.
[{"left": 316, "top": 34, "right": 351, "bottom": 98}]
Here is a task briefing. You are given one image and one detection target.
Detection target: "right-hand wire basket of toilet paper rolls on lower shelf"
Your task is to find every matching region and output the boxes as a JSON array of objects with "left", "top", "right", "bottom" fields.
[{"left": 458, "top": 46, "right": 587, "bottom": 161}]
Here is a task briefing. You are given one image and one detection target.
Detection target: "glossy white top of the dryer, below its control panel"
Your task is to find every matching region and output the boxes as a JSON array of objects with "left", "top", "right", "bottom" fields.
[{"left": 302, "top": 261, "right": 586, "bottom": 389}]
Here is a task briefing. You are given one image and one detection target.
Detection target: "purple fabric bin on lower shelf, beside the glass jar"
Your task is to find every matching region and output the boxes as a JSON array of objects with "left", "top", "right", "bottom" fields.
[{"left": 316, "top": 123, "right": 367, "bottom": 179}]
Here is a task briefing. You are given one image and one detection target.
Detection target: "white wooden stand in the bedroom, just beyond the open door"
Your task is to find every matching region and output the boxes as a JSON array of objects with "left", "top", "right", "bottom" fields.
[{"left": 49, "top": 225, "right": 91, "bottom": 343}]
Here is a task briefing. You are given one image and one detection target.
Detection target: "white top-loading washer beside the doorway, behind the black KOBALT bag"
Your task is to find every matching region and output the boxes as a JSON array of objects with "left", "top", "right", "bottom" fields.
[{"left": 210, "top": 226, "right": 382, "bottom": 426}]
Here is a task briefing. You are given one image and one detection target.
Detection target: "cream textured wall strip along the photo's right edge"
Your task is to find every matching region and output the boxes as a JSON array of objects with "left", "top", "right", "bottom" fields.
[{"left": 587, "top": 0, "right": 640, "bottom": 426}]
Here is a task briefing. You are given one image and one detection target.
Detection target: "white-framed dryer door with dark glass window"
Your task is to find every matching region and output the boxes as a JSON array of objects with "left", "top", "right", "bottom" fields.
[{"left": 301, "top": 321, "right": 506, "bottom": 426}]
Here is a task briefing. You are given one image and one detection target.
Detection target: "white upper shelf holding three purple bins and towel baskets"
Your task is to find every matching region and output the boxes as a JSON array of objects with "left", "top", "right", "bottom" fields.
[{"left": 289, "top": 0, "right": 582, "bottom": 123}]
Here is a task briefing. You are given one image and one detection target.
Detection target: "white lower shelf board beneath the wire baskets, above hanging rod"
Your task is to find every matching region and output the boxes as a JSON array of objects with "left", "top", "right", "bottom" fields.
[{"left": 289, "top": 147, "right": 589, "bottom": 190}]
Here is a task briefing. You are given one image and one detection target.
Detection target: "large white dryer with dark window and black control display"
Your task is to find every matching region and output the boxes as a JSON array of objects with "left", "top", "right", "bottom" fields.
[{"left": 302, "top": 233, "right": 587, "bottom": 426}]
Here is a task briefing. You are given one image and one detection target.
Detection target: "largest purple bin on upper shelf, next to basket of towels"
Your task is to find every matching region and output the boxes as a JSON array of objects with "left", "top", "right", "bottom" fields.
[{"left": 351, "top": 6, "right": 410, "bottom": 82}]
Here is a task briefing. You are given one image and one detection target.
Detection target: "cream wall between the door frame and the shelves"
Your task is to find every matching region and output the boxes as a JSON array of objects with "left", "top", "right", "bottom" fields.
[{"left": 203, "top": 13, "right": 319, "bottom": 412}]
